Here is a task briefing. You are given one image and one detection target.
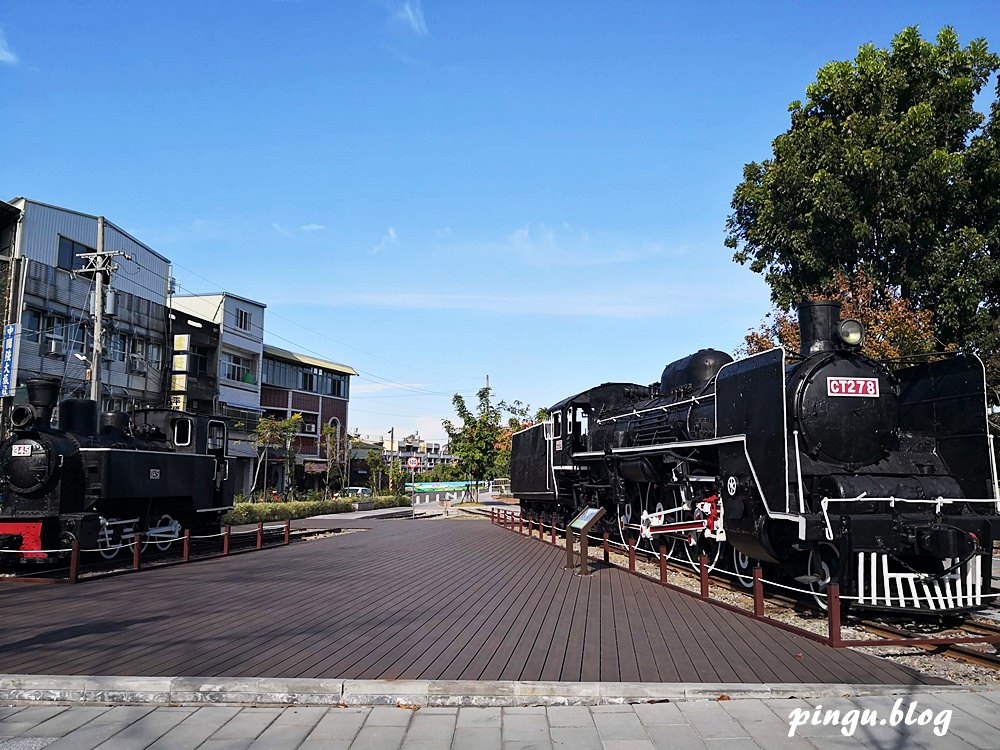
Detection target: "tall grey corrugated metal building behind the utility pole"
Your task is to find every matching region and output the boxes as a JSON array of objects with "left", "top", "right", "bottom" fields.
[{"left": 4, "top": 198, "right": 171, "bottom": 410}]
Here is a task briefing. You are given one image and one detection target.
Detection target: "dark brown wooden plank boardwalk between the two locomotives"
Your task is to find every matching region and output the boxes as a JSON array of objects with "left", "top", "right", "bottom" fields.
[{"left": 0, "top": 519, "right": 940, "bottom": 684}]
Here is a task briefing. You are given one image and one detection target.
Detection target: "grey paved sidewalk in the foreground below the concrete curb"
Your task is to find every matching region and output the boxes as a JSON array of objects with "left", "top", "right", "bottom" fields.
[{"left": 0, "top": 688, "right": 1000, "bottom": 750}]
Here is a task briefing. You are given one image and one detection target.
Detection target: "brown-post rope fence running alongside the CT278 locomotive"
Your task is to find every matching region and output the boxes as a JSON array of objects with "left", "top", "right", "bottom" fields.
[{"left": 490, "top": 508, "right": 1000, "bottom": 648}]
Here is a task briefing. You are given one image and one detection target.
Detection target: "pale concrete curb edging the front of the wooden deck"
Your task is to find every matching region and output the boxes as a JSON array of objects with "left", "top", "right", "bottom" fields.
[{"left": 0, "top": 674, "right": 1000, "bottom": 707}]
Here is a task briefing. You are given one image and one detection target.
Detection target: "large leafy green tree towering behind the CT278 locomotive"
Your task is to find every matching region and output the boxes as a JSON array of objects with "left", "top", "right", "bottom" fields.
[{"left": 726, "top": 26, "right": 1000, "bottom": 350}]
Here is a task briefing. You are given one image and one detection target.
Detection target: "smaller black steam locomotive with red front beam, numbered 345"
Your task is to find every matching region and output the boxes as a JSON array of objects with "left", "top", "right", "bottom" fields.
[{"left": 0, "top": 378, "right": 233, "bottom": 560}]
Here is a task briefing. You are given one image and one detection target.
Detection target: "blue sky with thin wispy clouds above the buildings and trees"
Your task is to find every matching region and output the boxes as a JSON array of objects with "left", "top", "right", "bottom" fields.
[{"left": 0, "top": 0, "right": 1000, "bottom": 439}]
